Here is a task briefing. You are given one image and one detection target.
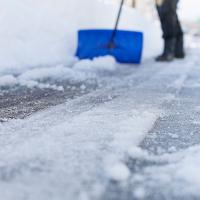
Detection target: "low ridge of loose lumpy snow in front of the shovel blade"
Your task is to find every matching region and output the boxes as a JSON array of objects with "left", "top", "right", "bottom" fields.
[{"left": 0, "top": 56, "right": 118, "bottom": 91}]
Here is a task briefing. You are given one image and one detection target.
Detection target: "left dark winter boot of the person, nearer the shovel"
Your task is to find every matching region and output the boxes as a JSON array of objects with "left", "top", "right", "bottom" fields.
[{"left": 156, "top": 39, "right": 176, "bottom": 62}]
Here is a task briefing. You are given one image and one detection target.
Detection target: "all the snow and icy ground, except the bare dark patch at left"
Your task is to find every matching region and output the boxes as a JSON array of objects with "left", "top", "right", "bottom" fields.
[{"left": 0, "top": 0, "right": 200, "bottom": 200}]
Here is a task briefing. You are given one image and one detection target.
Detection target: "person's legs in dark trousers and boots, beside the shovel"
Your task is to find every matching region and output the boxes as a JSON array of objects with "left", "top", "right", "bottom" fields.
[{"left": 156, "top": 0, "right": 183, "bottom": 61}]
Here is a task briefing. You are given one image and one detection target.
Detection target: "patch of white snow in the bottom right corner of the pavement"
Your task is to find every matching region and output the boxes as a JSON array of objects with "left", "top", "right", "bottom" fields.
[{"left": 132, "top": 145, "right": 200, "bottom": 197}]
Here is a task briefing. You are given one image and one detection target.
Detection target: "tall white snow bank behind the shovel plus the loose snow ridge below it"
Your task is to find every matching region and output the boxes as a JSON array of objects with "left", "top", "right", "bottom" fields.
[{"left": 0, "top": 0, "right": 161, "bottom": 91}]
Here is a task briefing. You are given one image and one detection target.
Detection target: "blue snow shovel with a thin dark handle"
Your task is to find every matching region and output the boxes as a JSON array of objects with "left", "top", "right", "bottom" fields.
[{"left": 76, "top": 0, "right": 143, "bottom": 64}]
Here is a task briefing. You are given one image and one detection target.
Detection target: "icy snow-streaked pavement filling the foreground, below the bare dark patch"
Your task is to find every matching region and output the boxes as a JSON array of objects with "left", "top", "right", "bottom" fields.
[{"left": 0, "top": 45, "right": 200, "bottom": 200}]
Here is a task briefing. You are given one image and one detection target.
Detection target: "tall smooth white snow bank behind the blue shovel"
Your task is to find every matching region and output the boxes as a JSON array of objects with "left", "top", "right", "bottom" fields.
[{"left": 0, "top": 0, "right": 159, "bottom": 74}]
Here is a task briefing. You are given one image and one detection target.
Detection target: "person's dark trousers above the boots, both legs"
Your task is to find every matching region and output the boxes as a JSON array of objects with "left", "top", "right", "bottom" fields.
[{"left": 157, "top": 0, "right": 183, "bottom": 40}]
